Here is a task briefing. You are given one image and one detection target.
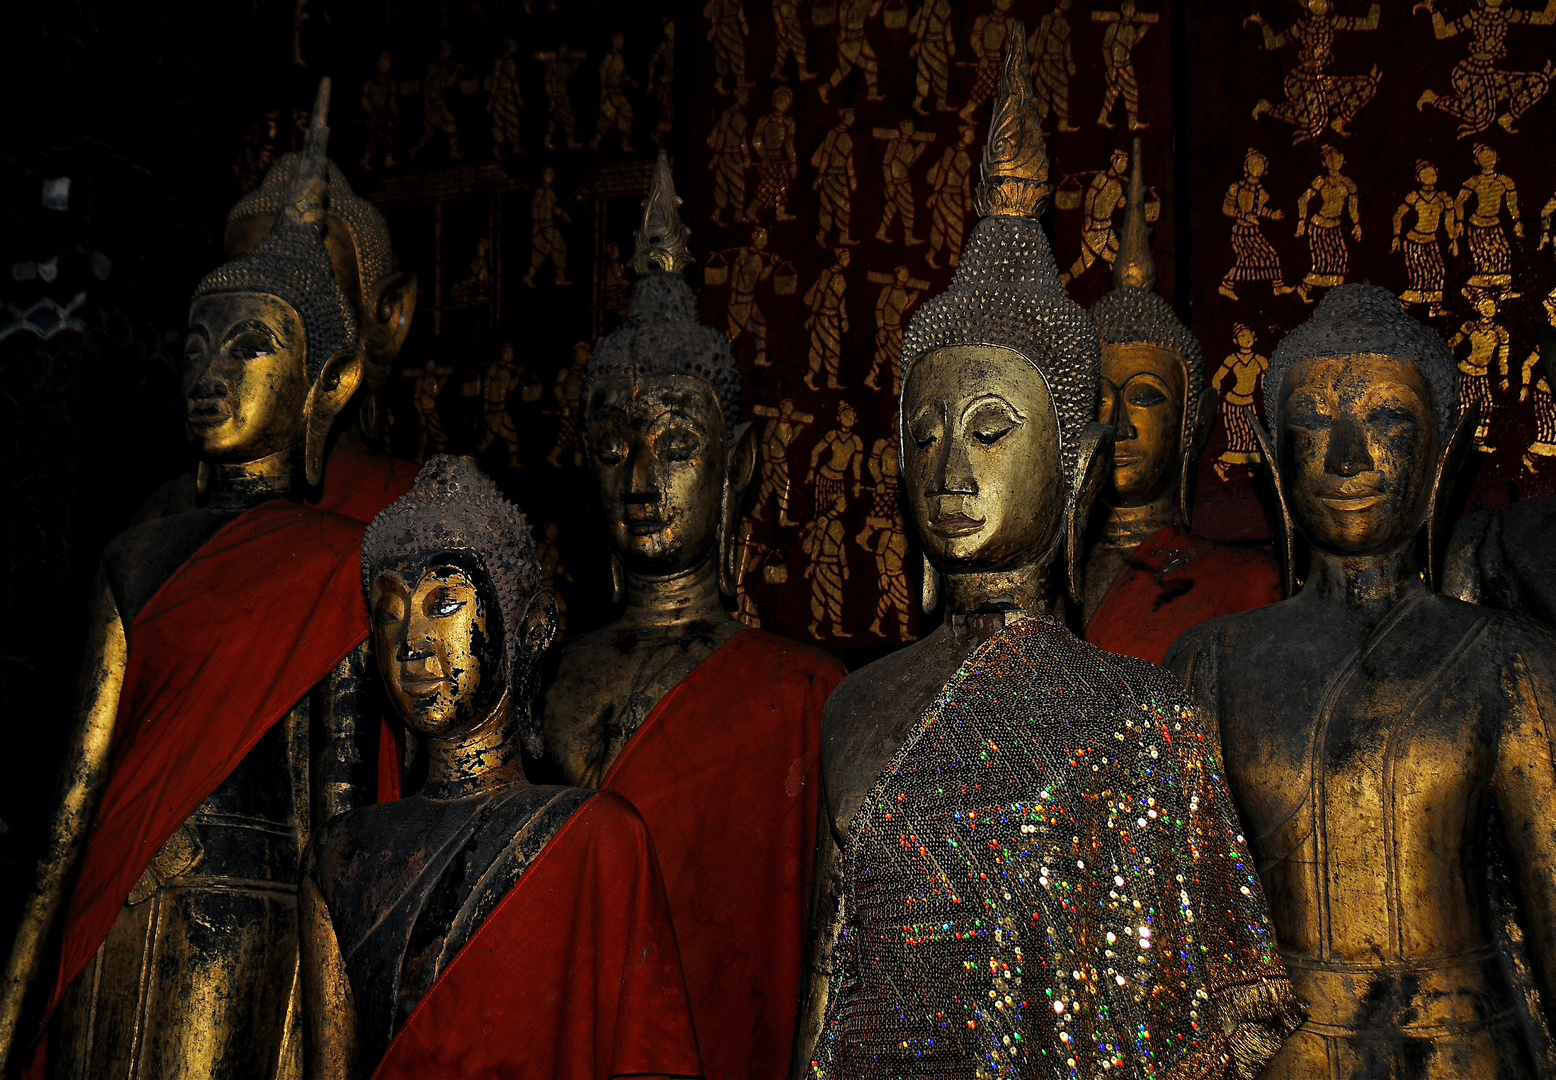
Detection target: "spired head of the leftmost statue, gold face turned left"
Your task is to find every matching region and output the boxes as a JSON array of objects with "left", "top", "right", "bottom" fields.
[{"left": 182, "top": 79, "right": 363, "bottom": 486}]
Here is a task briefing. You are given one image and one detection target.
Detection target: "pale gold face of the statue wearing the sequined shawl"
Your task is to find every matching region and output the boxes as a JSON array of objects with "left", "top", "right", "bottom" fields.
[{"left": 902, "top": 345, "right": 1064, "bottom": 573}]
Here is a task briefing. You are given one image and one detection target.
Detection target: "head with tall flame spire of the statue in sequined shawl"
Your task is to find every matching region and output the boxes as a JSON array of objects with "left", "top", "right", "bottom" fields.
[{"left": 899, "top": 25, "right": 1109, "bottom": 610}]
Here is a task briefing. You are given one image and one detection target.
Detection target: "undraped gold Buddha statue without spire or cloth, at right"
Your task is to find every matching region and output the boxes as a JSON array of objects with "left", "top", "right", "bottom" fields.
[{"left": 1167, "top": 285, "right": 1556, "bottom": 1080}]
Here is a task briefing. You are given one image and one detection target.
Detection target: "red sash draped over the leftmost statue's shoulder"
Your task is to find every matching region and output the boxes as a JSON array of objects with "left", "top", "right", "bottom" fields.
[{"left": 50, "top": 501, "right": 367, "bottom": 1012}]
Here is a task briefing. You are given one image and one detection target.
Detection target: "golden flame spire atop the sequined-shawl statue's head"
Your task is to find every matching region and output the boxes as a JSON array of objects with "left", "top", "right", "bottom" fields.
[{"left": 973, "top": 20, "right": 1053, "bottom": 218}]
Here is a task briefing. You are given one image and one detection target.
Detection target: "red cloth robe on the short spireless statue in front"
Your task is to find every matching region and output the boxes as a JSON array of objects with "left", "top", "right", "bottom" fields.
[{"left": 373, "top": 792, "right": 703, "bottom": 1080}]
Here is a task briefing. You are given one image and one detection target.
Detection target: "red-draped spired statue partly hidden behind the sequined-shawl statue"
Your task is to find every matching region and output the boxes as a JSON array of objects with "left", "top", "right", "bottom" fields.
[{"left": 1081, "top": 139, "right": 1282, "bottom": 663}]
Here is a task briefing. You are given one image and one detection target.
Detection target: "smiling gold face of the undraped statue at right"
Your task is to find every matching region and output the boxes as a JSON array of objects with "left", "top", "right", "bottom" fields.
[{"left": 1279, "top": 355, "right": 1436, "bottom": 556}]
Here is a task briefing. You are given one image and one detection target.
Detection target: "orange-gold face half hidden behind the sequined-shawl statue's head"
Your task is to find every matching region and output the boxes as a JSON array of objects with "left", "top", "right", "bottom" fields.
[{"left": 1102, "top": 344, "right": 1184, "bottom": 506}]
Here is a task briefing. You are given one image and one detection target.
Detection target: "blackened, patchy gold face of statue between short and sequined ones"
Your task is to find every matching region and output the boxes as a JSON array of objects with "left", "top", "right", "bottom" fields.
[{"left": 588, "top": 375, "right": 725, "bottom": 576}]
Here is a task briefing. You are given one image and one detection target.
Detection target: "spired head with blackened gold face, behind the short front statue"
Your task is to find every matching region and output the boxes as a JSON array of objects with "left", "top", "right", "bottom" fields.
[{"left": 584, "top": 151, "right": 756, "bottom": 596}]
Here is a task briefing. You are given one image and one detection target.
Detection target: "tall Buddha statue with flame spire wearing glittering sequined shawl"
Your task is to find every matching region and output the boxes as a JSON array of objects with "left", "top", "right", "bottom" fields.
[{"left": 792, "top": 23, "right": 1295, "bottom": 1078}]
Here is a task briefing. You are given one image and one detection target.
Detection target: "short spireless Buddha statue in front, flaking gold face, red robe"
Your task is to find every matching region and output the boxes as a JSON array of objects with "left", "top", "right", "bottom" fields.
[{"left": 300, "top": 454, "right": 702, "bottom": 1080}]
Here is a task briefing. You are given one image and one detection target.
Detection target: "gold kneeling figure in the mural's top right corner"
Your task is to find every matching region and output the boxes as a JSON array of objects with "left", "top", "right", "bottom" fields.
[{"left": 1411, "top": 0, "right": 1556, "bottom": 139}]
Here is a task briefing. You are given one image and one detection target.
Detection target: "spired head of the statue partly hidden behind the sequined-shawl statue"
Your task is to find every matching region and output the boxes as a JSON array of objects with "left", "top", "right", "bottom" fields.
[{"left": 1091, "top": 139, "right": 1215, "bottom": 524}]
